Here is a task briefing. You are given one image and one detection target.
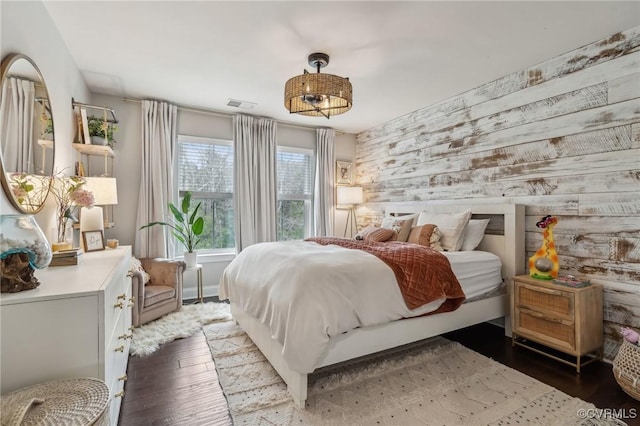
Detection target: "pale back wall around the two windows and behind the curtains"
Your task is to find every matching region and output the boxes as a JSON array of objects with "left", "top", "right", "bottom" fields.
[{"left": 89, "top": 94, "right": 355, "bottom": 298}]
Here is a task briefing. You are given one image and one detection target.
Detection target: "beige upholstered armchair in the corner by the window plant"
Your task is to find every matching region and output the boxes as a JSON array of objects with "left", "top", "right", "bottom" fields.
[{"left": 131, "top": 258, "right": 186, "bottom": 327}]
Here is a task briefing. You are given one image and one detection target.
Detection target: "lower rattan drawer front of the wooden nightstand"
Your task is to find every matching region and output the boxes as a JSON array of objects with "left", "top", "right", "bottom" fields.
[{"left": 516, "top": 309, "right": 576, "bottom": 350}]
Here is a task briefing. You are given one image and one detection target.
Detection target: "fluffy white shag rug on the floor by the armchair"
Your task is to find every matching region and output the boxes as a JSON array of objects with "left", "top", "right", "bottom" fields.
[{"left": 130, "top": 302, "right": 231, "bottom": 356}]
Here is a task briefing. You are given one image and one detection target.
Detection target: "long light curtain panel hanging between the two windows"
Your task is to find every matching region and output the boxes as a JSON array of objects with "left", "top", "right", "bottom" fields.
[{"left": 233, "top": 115, "right": 277, "bottom": 252}]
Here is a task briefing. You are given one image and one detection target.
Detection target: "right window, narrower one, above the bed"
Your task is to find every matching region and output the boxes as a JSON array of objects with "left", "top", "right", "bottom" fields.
[{"left": 276, "top": 146, "right": 314, "bottom": 240}]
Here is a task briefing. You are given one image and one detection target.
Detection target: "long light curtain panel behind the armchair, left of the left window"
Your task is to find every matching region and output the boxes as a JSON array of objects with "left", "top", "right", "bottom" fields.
[{"left": 134, "top": 100, "right": 178, "bottom": 257}]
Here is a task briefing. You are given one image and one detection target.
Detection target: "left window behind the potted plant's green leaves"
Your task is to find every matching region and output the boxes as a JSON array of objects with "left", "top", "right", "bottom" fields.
[{"left": 176, "top": 135, "right": 235, "bottom": 255}]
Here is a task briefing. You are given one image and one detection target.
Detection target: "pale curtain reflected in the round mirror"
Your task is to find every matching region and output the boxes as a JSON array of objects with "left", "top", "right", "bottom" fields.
[{"left": 0, "top": 77, "right": 36, "bottom": 173}]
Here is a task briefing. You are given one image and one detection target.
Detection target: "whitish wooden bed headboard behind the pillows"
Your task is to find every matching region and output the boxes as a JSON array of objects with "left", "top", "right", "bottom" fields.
[{"left": 381, "top": 202, "right": 525, "bottom": 282}]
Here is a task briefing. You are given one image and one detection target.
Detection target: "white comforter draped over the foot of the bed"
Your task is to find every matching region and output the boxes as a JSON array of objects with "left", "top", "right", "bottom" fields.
[{"left": 219, "top": 241, "right": 444, "bottom": 374}]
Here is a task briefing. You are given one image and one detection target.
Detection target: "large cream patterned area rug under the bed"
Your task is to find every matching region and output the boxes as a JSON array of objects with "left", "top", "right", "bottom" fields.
[{"left": 203, "top": 321, "right": 621, "bottom": 426}]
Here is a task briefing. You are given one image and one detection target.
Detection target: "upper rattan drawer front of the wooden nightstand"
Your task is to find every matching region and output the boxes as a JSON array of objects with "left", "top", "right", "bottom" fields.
[{"left": 516, "top": 284, "right": 574, "bottom": 320}]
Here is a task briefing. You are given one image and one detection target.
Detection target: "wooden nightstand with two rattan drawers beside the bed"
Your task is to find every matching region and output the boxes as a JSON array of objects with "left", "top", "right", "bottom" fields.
[{"left": 511, "top": 275, "right": 603, "bottom": 373}]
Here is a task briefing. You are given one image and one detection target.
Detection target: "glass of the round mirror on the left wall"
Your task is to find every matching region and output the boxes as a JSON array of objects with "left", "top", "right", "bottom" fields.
[{"left": 0, "top": 54, "right": 55, "bottom": 214}]
